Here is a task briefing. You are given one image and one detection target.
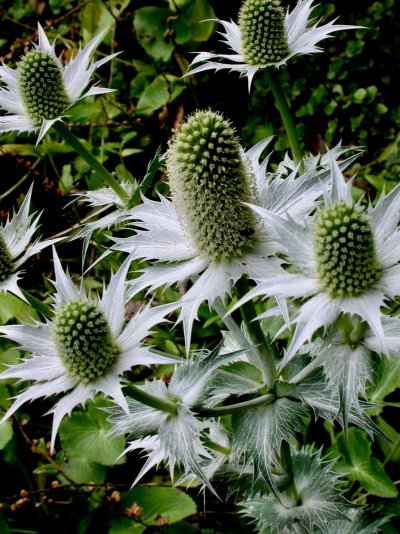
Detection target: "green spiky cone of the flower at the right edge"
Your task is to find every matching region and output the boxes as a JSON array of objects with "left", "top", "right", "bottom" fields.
[{"left": 313, "top": 202, "right": 380, "bottom": 297}]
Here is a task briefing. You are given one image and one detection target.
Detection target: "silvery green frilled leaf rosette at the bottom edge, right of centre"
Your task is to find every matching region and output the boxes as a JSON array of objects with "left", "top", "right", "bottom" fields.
[{"left": 241, "top": 447, "right": 348, "bottom": 534}]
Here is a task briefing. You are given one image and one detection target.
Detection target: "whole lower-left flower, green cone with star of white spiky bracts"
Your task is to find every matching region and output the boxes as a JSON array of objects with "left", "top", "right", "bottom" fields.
[{"left": 0, "top": 251, "right": 177, "bottom": 449}]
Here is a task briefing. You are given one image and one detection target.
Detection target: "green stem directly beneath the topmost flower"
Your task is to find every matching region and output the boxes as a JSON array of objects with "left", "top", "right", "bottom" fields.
[{"left": 266, "top": 67, "right": 303, "bottom": 171}]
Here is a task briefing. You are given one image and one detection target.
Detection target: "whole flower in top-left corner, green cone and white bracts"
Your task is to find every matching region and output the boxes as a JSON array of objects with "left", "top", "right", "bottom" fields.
[{"left": 0, "top": 23, "right": 117, "bottom": 143}]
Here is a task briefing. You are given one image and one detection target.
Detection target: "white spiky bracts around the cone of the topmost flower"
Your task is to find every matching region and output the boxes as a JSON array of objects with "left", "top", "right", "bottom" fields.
[{"left": 186, "top": 0, "right": 358, "bottom": 91}]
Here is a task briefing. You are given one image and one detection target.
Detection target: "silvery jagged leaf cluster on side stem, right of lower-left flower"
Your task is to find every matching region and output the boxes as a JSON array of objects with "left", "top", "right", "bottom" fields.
[{"left": 106, "top": 350, "right": 242, "bottom": 493}]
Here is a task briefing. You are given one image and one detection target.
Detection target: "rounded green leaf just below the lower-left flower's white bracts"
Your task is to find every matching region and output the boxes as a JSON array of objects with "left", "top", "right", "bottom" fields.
[{"left": 59, "top": 401, "right": 126, "bottom": 465}]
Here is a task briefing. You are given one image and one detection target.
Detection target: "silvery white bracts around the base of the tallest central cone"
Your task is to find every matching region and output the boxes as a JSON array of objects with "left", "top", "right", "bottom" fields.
[{"left": 114, "top": 138, "right": 321, "bottom": 351}]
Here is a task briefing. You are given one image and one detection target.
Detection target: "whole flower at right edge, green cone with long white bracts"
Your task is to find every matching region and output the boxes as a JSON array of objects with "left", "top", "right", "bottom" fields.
[{"left": 233, "top": 153, "right": 400, "bottom": 363}]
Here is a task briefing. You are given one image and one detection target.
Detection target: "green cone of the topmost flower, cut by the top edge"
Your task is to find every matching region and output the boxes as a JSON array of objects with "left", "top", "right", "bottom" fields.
[{"left": 239, "top": 0, "right": 289, "bottom": 65}]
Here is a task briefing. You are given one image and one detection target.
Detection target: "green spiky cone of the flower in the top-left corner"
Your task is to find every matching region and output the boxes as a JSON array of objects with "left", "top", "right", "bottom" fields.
[{"left": 18, "top": 50, "right": 69, "bottom": 121}]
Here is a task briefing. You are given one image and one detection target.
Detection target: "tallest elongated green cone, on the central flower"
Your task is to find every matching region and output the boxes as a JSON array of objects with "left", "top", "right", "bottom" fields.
[{"left": 167, "top": 111, "right": 256, "bottom": 262}]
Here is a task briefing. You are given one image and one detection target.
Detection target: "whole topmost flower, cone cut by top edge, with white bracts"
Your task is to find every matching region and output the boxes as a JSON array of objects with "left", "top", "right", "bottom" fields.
[{"left": 187, "top": 0, "right": 358, "bottom": 90}]
